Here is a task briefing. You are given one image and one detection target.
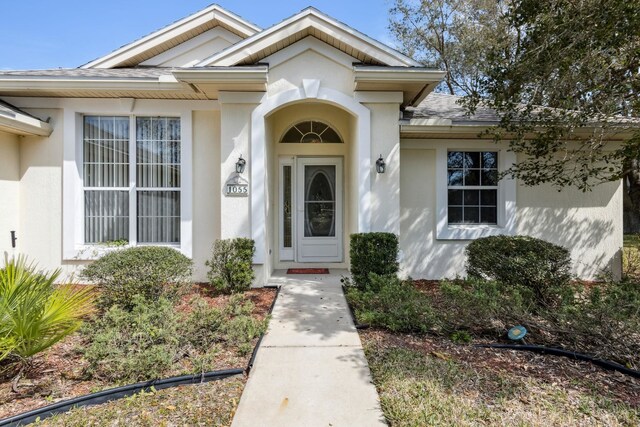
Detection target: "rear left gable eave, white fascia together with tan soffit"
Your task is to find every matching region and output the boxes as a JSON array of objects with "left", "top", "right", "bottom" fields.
[{"left": 80, "top": 4, "right": 260, "bottom": 68}]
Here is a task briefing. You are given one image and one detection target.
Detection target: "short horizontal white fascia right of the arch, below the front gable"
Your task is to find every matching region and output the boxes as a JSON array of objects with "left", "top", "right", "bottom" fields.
[{"left": 353, "top": 66, "right": 447, "bottom": 83}]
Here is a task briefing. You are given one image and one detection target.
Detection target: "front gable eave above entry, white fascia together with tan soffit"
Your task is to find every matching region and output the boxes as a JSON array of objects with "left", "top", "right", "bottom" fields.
[{"left": 196, "top": 7, "right": 422, "bottom": 67}]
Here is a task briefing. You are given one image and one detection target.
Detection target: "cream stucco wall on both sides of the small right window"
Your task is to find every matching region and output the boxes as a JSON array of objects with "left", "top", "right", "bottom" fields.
[{"left": 400, "top": 149, "right": 622, "bottom": 279}]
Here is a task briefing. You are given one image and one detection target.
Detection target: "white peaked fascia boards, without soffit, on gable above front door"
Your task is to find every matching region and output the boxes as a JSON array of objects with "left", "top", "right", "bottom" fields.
[{"left": 196, "top": 7, "right": 422, "bottom": 67}]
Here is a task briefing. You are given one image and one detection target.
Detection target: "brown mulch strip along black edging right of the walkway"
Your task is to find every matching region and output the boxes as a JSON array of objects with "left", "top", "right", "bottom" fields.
[{"left": 360, "top": 329, "right": 640, "bottom": 407}]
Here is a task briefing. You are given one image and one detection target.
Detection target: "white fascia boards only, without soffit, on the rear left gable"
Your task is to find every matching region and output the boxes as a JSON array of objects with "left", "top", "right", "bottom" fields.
[{"left": 80, "top": 5, "right": 260, "bottom": 68}]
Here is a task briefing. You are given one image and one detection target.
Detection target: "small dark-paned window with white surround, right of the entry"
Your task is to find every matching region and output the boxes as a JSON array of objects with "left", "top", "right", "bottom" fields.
[{"left": 436, "top": 146, "right": 516, "bottom": 240}]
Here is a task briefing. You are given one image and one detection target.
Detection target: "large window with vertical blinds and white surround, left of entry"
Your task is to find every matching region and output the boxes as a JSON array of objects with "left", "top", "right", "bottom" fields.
[{"left": 64, "top": 99, "right": 198, "bottom": 261}]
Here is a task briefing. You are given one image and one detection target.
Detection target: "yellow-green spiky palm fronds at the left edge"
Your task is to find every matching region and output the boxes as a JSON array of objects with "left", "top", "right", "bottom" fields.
[{"left": 0, "top": 257, "right": 95, "bottom": 361}]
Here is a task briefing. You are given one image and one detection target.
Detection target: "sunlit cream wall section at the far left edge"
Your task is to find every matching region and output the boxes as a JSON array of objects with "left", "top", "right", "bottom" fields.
[{"left": 0, "top": 132, "right": 21, "bottom": 265}]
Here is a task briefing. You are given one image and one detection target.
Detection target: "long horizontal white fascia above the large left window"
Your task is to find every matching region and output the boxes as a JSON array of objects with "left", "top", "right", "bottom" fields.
[{"left": 0, "top": 76, "right": 186, "bottom": 91}]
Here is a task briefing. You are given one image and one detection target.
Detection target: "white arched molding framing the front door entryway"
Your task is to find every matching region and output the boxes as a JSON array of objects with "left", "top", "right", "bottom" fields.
[{"left": 250, "top": 87, "right": 372, "bottom": 264}]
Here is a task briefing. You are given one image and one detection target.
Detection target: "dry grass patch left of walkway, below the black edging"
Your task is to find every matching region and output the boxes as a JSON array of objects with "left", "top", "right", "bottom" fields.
[{"left": 35, "top": 378, "right": 244, "bottom": 427}]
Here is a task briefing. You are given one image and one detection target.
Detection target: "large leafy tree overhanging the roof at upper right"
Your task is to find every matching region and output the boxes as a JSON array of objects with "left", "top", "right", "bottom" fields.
[{"left": 467, "top": 0, "right": 640, "bottom": 190}]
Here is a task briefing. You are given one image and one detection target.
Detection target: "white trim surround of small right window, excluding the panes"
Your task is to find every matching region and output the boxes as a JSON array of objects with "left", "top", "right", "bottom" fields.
[{"left": 436, "top": 145, "right": 516, "bottom": 240}]
